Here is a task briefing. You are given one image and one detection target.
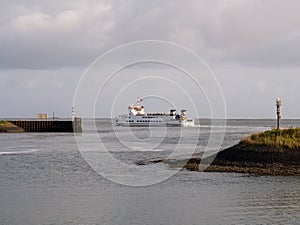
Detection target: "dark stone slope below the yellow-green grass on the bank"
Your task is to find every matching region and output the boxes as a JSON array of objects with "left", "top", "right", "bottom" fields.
[{"left": 184, "top": 143, "right": 300, "bottom": 176}]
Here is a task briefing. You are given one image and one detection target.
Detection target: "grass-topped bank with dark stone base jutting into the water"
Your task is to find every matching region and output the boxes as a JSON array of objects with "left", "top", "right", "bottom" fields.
[{"left": 185, "top": 128, "right": 300, "bottom": 176}]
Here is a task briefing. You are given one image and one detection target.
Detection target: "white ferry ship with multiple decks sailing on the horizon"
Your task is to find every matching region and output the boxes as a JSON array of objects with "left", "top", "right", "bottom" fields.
[{"left": 116, "top": 99, "right": 194, "bottom": 127}]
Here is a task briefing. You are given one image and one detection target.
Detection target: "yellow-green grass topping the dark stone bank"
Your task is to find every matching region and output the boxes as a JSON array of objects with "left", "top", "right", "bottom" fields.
[{"left": 241, "top": 128, "right": 300, "bottom": 149}]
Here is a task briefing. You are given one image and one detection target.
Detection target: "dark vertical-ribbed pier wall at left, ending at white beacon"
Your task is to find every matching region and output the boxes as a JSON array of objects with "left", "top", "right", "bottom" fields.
[{"left": 8, "top": 117, "right": 82, "bottom": 133}]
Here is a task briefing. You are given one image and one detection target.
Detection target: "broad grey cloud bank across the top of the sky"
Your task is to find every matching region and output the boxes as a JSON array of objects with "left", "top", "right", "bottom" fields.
[{"left": 0, "top": 0, "right": 300, "bottom": 68}]
